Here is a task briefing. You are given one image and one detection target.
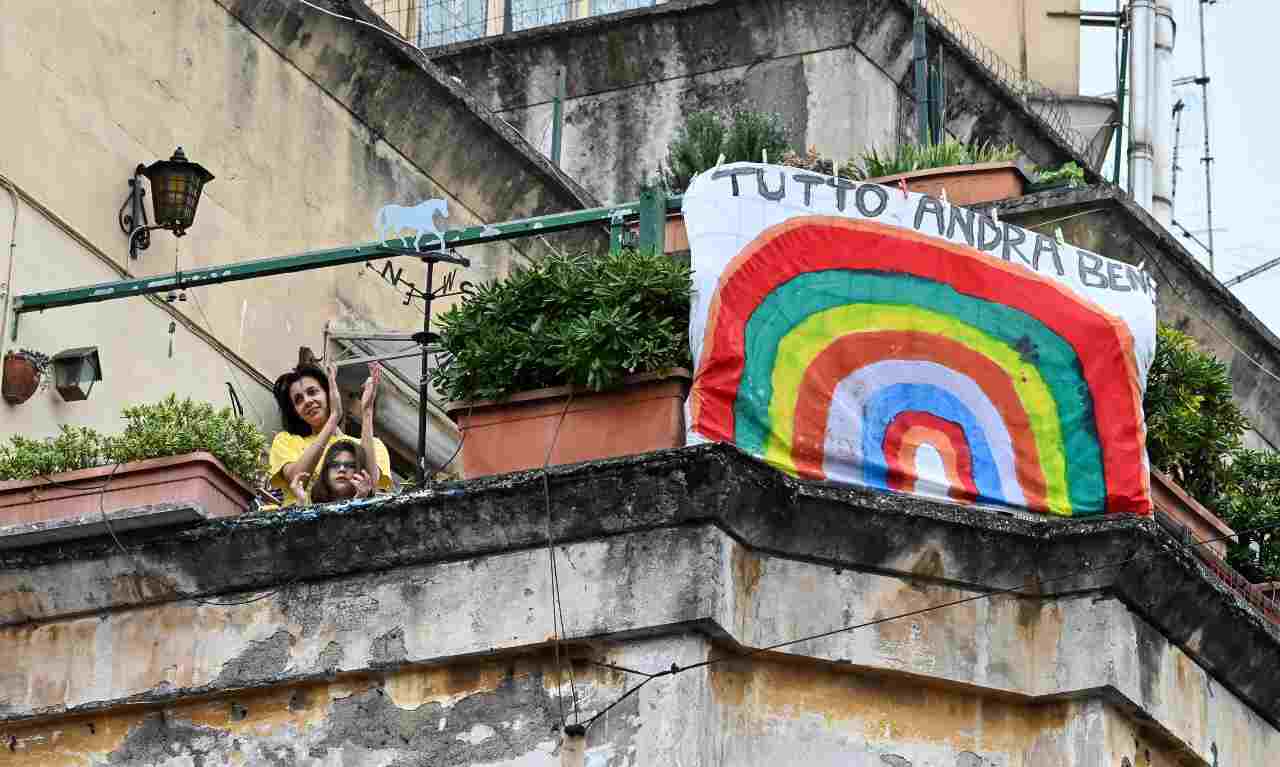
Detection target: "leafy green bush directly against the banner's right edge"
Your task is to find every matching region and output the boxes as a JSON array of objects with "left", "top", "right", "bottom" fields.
[{"left": 1143, "top": 325, "right": 1245, "bottom": 506}]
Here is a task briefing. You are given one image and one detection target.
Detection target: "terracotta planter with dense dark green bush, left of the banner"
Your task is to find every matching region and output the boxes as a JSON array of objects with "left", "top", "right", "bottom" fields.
[{"left": 433, "top": 250, "right": 691, "bottom": 478}]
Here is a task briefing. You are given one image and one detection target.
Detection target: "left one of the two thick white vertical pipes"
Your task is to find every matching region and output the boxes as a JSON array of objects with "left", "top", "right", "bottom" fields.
[{"left": 1129, "top": 0, "right": 1156, "bottom": 210}]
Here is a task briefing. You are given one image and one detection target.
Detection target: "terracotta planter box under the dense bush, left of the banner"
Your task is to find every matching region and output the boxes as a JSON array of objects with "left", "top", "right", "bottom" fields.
[{"left": 447, "top": 369, "right": 691, "bottom": 479}]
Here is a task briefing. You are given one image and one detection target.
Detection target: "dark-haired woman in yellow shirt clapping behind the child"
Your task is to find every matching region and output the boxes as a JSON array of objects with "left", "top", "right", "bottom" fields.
[{"left": 270, "top": 365, "right": 392, "bottom": 506}]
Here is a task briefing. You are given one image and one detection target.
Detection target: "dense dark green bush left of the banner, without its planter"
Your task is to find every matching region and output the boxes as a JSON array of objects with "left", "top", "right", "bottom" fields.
[{"left": 433, "top": 250, "right": 692, "bottom": 400}]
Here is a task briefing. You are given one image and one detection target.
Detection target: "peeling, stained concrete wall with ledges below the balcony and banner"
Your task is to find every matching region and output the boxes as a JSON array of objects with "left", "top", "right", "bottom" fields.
[{"left": 0, "top": 447, "right": 1280, "bottom": 767}]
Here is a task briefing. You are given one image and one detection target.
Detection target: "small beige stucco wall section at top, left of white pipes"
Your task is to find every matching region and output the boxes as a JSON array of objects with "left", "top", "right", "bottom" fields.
[{"left": 929, "top": 0, "right": 1080, "bottom": 95}]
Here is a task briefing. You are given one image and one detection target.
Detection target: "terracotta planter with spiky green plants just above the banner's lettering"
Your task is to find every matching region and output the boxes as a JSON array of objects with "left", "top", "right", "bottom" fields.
[{"left": 851, "top": 138, "right": 1029, "bottom": 205}]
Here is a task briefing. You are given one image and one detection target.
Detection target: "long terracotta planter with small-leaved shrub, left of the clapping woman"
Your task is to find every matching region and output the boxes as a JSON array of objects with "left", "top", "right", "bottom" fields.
[{"left": 0, "top": 394, "right": 266, "bottom": 528}]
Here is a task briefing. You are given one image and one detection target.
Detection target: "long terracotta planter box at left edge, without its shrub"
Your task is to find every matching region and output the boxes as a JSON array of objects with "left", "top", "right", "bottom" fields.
[{"left": 0, "top": 452, "right": 253, "bottom": 533}]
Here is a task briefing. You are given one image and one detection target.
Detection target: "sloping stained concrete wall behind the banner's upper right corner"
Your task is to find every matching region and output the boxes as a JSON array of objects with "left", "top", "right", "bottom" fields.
[{"left": 1000, "top": 186, "right": 1280, "bottom": 449}]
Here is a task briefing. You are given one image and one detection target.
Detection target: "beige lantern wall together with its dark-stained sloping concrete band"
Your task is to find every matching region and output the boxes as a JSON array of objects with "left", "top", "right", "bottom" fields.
[{"left": 0, "top": 0, "right": 590, "bottom": 460}]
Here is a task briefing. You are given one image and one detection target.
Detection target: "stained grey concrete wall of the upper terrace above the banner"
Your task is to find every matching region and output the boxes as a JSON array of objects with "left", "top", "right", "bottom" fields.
[{"left": 431, "top": 0, "right": 1083, "bottom": 207}]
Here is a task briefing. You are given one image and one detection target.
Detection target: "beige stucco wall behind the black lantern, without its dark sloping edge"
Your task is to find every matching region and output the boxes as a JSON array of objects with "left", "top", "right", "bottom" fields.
[{"left": 0, "top": 0, "right": 535, "bottom": 453}]
